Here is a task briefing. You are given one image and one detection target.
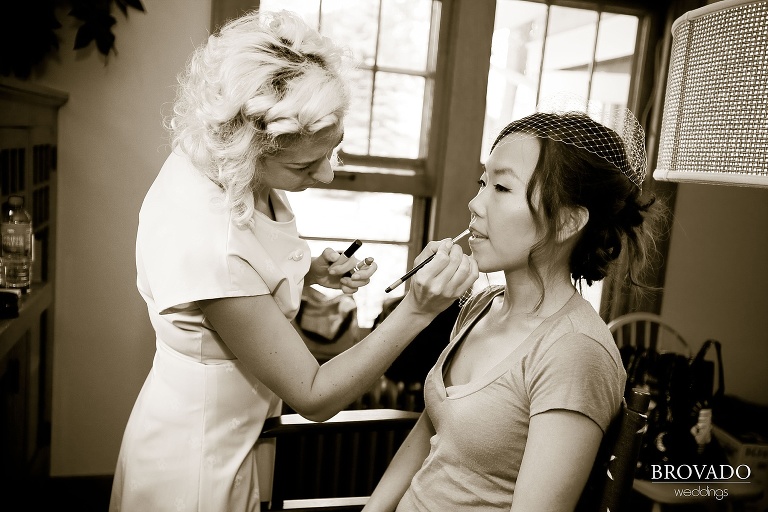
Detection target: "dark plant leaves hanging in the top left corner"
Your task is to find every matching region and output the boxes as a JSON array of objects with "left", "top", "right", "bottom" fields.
[{"left": 0, "top": 0, "right": 144, "bottom": 79}]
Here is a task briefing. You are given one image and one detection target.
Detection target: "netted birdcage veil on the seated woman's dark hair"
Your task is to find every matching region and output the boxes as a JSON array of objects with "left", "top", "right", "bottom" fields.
[{"left": 491, "top": 94, "right": 647, "bottom": 189}]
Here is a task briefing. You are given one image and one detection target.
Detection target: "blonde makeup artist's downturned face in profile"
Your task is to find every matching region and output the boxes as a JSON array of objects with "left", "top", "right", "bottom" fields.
[{"left": 262, "top": 126, "right": 344, "bottom": 192}]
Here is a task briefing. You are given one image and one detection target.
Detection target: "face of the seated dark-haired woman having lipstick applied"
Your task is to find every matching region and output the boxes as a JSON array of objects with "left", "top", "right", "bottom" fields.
[{"left": 469, "top": 133, "right": 541, "bottom": 272}]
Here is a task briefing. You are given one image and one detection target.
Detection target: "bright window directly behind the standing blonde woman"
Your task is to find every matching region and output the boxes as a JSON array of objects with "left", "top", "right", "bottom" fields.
[{"left": 260, "top": 0, "right": 441, "bottom": 327}]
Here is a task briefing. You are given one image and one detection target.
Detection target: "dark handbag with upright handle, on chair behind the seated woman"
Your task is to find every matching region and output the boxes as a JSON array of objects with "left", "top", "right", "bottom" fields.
[{"left": 627, "top": 339, "right": 727, "bottom": 480}]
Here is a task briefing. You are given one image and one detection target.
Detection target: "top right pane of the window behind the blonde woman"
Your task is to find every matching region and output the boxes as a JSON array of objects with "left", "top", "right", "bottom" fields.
[{"left": 377, "top": 0, "right": 432, "bottom": 71}]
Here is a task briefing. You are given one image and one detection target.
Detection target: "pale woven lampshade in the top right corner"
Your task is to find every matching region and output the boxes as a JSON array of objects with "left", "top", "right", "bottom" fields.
[{"left": 653, "top": 0, "right": 768, "bottom": 187}]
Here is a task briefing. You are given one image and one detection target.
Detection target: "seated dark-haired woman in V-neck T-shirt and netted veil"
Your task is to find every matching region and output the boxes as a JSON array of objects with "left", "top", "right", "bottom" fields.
[{"left": 364, "top": 108, "right": 659, "bottom": 512}]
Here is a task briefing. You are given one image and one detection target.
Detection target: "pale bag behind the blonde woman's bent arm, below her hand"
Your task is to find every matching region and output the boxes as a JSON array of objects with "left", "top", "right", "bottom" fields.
[{"left": 293, "top": 286, "right": 360, "bottom": 363}]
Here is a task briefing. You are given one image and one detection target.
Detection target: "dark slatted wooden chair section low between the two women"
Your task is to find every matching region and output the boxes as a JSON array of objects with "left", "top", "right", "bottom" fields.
[{"left": 259, "top": 409, "right": 420, "bottom": 511}]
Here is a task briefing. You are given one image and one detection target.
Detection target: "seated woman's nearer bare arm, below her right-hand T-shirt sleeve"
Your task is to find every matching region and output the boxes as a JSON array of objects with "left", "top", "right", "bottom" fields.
[{"left": 512, "top": 410, "right": 603, "bottom": 512}]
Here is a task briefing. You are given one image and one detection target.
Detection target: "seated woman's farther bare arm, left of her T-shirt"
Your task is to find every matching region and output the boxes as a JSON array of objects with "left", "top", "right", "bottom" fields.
[{"left": 363, "top": 412, "right": 435, "bottom": 512}]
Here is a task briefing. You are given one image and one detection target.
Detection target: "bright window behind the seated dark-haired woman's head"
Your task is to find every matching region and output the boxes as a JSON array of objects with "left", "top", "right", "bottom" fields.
[{"left": 481, "top": 0, "right": 640, "bottom": 311}]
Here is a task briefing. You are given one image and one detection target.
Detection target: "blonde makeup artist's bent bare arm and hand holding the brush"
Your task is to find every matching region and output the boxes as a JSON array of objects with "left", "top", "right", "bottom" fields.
[{"left": 200, "top": 240, "right": 477, "bottom": 421}]
